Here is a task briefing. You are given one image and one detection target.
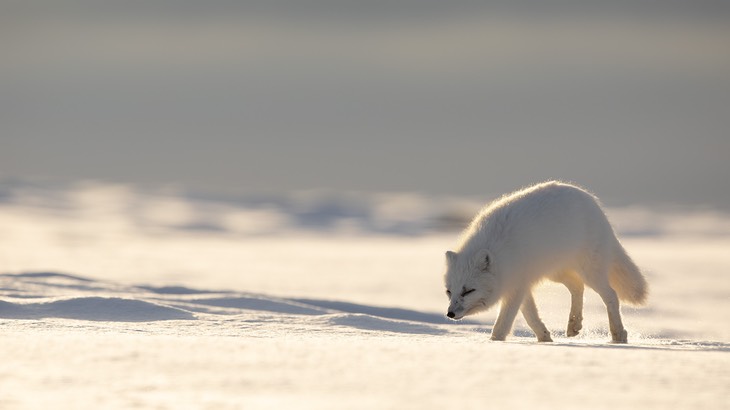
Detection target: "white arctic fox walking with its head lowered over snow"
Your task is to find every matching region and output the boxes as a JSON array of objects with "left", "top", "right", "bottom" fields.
[{"left": 445, "top": 181, "right": 647, "bottom": 343}]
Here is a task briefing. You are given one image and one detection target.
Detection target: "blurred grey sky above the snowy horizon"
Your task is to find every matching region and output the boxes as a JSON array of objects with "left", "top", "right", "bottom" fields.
[{"left": 0, "top": 0, "right": 730, "bottom": 209}]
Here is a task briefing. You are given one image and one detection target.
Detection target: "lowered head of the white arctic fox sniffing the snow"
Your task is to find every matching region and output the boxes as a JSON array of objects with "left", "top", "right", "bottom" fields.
[{"left": 444, "top": 249, "right": 499, "bottom": 320}]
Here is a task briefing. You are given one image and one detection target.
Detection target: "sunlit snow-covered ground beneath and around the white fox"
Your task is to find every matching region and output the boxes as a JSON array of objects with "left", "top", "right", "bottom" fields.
[{"left": 0, "top": 183, "right": 730, "bottom": 409}]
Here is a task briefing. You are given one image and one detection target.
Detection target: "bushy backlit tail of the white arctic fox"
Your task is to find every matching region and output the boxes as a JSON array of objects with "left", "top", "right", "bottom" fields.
[{"left": 608, "top": 241, "right": 649, "bottom": 305}]
